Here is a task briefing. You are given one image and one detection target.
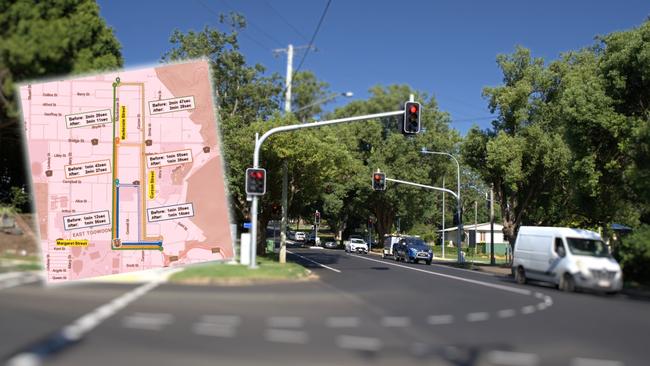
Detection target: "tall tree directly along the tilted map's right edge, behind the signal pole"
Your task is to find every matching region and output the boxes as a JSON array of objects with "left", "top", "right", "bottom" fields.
[{"left": 162, "top": 13, "right": 282, "bottom": 226}]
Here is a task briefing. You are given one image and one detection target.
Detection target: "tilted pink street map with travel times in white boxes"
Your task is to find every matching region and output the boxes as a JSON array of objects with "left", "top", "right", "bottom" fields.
[{"left": 20, "top": 60, "right": 233, "bottom": 282}]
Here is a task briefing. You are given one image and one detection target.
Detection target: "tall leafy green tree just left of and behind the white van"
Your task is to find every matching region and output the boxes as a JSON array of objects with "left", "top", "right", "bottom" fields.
[{"left": 462, "top": 47, "right": 570, "bottom": 244}]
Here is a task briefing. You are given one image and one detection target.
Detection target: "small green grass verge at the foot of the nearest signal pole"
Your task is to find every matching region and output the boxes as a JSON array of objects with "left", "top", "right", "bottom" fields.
[{"left": 169, "top": 255, "right": 311, "bottom": 285}]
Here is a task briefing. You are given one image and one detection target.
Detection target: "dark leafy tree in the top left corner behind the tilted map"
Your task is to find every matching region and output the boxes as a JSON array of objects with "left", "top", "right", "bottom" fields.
[{"left": 0, "top": 0, "right": 122, "bottom": 208}]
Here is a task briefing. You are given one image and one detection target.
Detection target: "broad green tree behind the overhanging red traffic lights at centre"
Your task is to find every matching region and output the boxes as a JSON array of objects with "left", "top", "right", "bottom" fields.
[{"left": 326, "top": 85, "right": 458, "bottom": 242}]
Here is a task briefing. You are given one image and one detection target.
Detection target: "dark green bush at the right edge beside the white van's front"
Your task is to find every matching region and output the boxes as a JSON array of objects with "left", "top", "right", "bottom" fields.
[{"left": 615, "top": 225, "right": 650, "bottom": 284}]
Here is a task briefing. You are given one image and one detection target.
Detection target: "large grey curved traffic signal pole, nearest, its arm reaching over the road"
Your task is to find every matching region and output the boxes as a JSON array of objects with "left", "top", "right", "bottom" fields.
[{"left": 250, "top": 110, "right": 404, "bottom": 268}]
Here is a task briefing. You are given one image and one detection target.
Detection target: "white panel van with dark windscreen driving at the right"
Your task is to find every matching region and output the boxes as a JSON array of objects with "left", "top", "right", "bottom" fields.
[{"left": 512, "top": 226, "right": 623, "bottom": 292}]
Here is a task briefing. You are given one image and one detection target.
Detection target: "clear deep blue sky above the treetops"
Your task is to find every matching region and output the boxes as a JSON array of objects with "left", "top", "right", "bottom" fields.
[{"left": 98, "top": 0, "right": 650, "bottom": 134}]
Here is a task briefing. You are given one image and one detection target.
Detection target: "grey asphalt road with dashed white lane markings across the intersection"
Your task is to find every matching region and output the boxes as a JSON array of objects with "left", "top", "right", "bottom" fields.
[{"left": 0, "top": 248, "right": 650, "bottom": 366}]
